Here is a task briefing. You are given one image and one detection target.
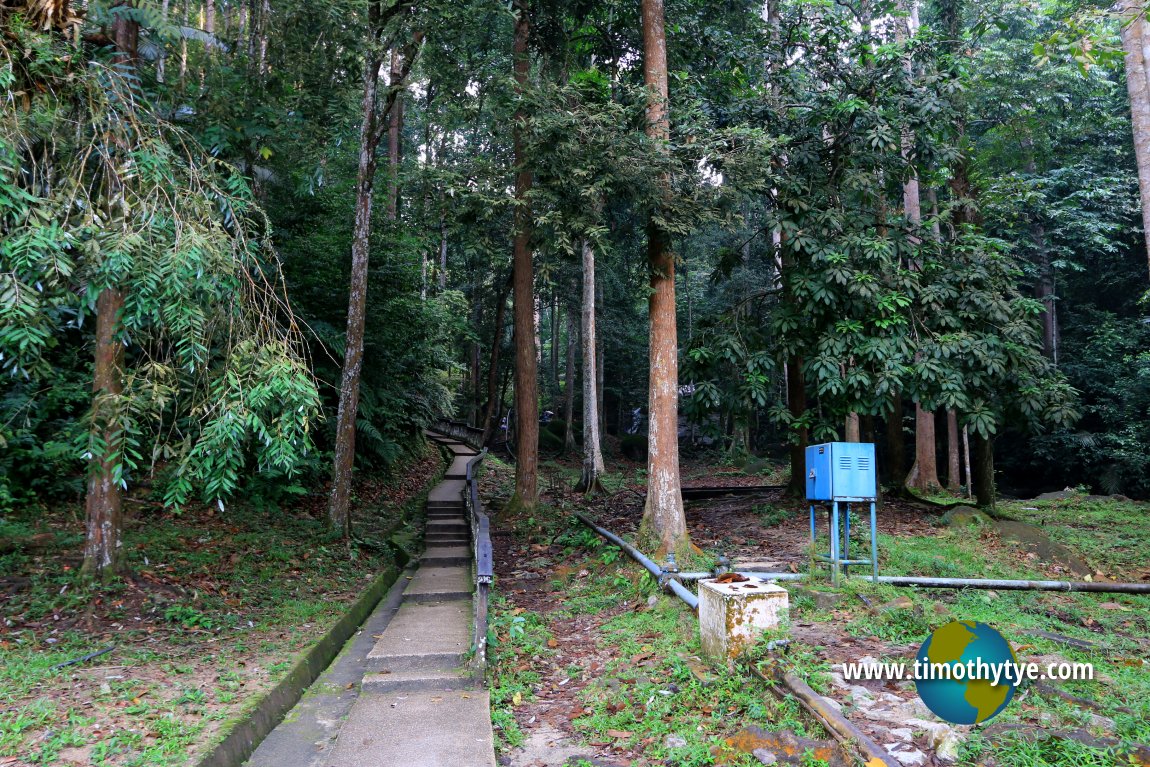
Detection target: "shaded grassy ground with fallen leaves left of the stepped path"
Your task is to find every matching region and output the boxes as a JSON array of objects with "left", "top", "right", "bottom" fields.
[{"left": 0, "top": 448, "right": 443, "bottom": 767}]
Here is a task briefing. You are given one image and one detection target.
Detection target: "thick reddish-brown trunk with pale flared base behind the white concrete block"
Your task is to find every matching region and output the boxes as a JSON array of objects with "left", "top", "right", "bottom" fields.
[{"left": 642, "top": 0, "right": 690, "bottom": 554}]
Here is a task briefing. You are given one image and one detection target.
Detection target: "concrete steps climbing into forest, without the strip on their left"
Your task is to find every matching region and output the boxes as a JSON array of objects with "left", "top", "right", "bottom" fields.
[{"left": 323, "top": 435, "right": 496, "bottom": 767}]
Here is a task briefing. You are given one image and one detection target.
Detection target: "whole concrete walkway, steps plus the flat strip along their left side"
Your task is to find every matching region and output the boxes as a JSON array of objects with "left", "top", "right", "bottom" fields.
[{"left": 247, "top": 434, "right": 496, "bottom": 767}]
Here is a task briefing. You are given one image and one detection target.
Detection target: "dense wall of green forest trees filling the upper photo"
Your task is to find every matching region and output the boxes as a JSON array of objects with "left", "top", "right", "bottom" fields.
[{"left": 0, "top": 0, "right": 1150, "bottom": 570}]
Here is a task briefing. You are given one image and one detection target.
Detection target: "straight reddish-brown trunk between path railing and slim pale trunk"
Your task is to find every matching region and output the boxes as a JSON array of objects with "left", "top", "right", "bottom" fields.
[{"left": 512, "top": 2, "right": 539, "bottom": 509}]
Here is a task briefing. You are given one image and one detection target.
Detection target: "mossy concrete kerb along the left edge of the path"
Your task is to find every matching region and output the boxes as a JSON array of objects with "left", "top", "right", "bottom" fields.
[{"left": 193, "top": 569, "right": 400, "bottom": 767}]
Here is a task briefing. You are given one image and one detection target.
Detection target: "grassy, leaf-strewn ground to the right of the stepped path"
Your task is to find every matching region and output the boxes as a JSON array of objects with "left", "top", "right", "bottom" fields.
[{"left": 484, "top": 453, "right": 1150, "bottom": 767}]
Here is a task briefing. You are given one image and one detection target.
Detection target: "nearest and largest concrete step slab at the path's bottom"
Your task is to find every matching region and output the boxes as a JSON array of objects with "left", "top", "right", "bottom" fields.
[{"left": 323, "top": 690, "right": 496, "bottom": 767}]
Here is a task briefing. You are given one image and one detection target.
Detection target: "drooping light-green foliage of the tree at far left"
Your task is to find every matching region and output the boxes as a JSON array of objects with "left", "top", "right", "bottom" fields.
[{"left": 0, "top": 22, "right": 319, "bottom": 505}]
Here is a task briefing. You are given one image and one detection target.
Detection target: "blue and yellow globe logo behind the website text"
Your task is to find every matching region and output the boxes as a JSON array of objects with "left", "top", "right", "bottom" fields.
[{"left": 914, "top": 621, "right": 1019, "bottom": 724}]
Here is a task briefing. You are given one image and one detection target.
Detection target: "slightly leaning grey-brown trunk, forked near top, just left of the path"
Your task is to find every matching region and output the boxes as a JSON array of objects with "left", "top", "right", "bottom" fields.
[{"left": 328, "top": 17, "right": 423, "bottom": 539}]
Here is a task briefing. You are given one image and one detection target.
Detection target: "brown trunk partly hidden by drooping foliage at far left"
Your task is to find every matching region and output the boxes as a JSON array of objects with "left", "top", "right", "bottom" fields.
[{"left": 81, "top": 2, "right": 139, "bottom": 581}]
